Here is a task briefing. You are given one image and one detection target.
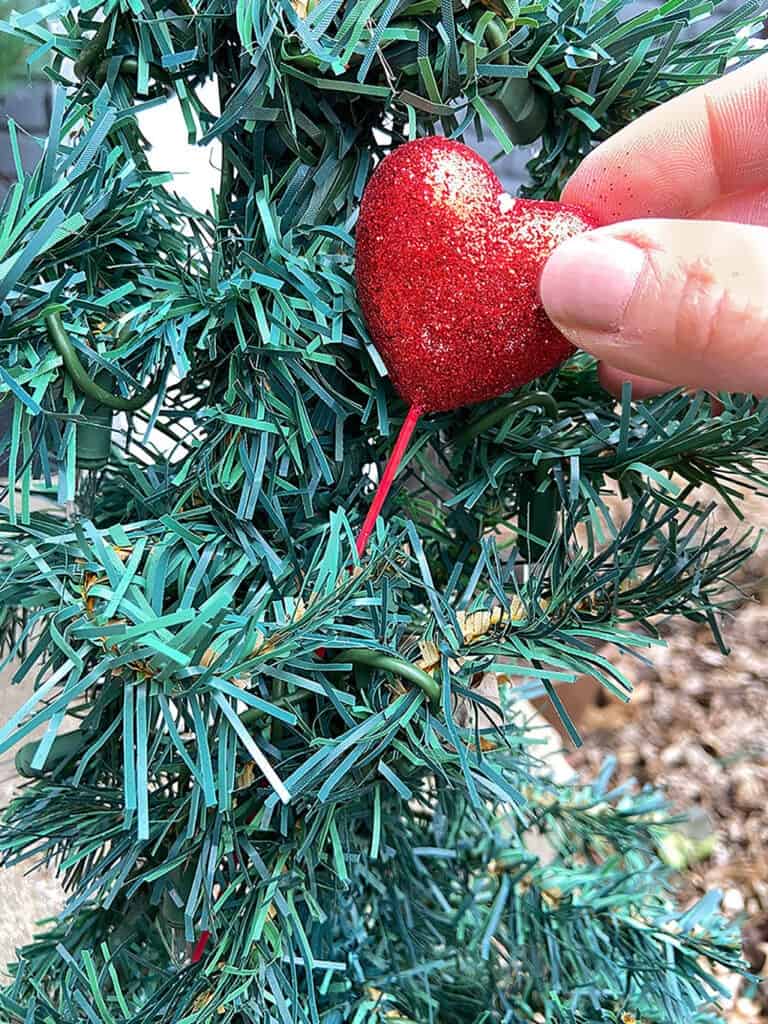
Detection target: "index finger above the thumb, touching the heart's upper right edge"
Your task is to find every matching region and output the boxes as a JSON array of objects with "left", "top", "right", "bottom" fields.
[{"left": 562, "top": 55, "right": 768, "bottom": 224}]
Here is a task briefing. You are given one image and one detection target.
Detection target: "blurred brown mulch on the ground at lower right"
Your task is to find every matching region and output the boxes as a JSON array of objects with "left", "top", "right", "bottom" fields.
[{"left": 568, "top": 505, "right": 768, "bottom": 1024}]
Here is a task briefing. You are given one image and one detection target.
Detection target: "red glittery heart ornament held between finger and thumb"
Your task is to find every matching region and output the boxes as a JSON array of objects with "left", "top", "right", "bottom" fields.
[{"left": 355, "top": 136, "right": 597, "bottom": 413}]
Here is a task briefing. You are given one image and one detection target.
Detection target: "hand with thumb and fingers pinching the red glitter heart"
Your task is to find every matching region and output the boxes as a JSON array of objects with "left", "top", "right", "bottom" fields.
[{"left": 541, "top": 55, "right": 768, "bottom": 397}]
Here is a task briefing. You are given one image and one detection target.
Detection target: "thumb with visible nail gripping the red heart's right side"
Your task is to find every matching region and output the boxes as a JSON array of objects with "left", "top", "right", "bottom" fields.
[{"left": 541, "top": 220, "right": 768, "bottom": 395}]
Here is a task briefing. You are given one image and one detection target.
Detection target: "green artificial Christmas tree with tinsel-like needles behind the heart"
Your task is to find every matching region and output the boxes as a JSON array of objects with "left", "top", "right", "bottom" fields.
[{"left": 0, "top": 0, "right": 768, "bottom": 1024}]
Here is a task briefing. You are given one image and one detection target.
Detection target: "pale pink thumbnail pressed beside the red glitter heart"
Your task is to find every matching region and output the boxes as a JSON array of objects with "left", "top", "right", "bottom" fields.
[{"left": 541, "top": 234, "right": 645, "bottom": 332}]
